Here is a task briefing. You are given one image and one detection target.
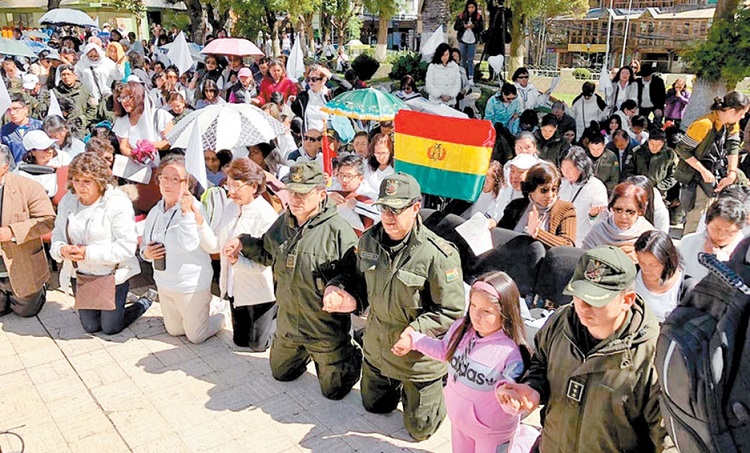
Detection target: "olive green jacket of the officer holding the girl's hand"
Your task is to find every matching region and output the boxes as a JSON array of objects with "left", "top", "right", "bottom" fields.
[{"left": 332, "top": 217, "right": 465, "bottom": 382}]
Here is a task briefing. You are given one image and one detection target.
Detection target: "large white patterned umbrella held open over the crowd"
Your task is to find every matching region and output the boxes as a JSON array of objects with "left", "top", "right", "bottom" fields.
[{"left": 167, "top": 104, "right": 286, "bottom": 150}]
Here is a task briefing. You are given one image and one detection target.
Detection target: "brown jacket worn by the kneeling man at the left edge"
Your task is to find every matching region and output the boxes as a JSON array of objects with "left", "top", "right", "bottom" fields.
[{"left": 0, "top": 173, "right": 55, "bottom": 297}]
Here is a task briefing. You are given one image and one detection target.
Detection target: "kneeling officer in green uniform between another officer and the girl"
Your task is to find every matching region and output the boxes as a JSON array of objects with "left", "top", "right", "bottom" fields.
[{"left": 323, "top": 173, "right": 465, "bottom": 441}]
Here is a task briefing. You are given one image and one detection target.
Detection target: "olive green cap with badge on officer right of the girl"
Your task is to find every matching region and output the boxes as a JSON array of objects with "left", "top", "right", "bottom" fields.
[{"left": 563, "top": 245, "right": 637, "bottom": 307}]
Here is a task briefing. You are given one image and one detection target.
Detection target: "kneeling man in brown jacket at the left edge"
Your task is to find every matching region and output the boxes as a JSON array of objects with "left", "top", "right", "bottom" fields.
[{"left": 0, "top": 146, "right": 55, "bottom": 317}]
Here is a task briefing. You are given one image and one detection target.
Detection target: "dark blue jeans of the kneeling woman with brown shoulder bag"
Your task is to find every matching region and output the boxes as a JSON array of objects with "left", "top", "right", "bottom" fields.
[{"left": 77, "top": 279, "right": 148, "bottom": 335}]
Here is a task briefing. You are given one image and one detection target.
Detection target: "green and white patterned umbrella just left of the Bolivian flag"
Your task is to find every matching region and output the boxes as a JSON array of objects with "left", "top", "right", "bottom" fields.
[{"left": 321, "top": 88, "right": 409, "bottom": 121}]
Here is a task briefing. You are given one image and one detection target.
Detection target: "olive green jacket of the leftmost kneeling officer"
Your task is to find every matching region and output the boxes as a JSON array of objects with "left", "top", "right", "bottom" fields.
[{"left": 240, "top": 201, "right": 357, "bottom": 345}]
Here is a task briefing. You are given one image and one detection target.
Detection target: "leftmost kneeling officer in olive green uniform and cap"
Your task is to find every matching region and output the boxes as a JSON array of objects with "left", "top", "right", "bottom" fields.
[{"left": 231, "top": 162, "right": 362, "bottom": 400}]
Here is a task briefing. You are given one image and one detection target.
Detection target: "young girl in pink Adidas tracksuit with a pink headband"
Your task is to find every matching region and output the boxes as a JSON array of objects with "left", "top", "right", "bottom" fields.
[{"left": 393, "top": 272, "right": 538, "bottom": 453}]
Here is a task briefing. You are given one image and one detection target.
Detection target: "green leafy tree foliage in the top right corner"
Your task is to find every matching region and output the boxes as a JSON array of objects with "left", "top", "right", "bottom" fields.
[{"left": 685, "top": 7, "right": 750, "bottom": 85}]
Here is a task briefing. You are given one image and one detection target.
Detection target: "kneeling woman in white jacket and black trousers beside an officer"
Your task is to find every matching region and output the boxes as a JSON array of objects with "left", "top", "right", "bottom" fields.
[{"left": 201, "top": 157, "right": 278, "bottom": 352}]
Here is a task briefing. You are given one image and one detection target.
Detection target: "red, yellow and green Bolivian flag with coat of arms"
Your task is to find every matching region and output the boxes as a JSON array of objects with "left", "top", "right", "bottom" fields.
[{"left": 394, "top": 110, "right": 495, "bottom": 202}]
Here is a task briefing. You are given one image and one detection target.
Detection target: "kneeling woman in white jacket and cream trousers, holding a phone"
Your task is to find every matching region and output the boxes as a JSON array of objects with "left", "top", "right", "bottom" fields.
[{"left": 141, "top": 154, "right": 225, "bottom": 343}]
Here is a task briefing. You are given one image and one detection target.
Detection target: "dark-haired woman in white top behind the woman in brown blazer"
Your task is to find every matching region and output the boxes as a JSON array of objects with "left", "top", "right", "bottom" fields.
[{"left": 559, "top": 146, "right": 607, "bottom": 247}]
